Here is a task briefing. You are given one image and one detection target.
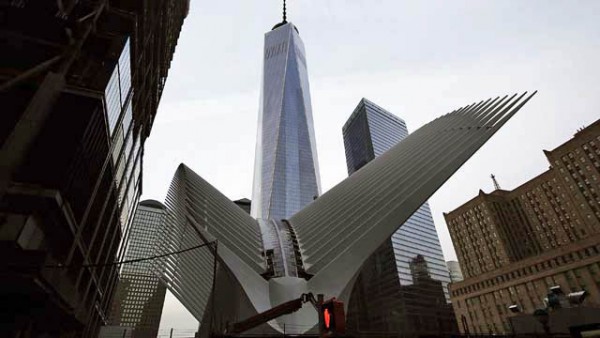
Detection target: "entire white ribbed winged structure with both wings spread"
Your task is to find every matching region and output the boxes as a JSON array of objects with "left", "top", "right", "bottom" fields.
[{"left": 155, "top": 92, "right": 535, "bottom": 333}]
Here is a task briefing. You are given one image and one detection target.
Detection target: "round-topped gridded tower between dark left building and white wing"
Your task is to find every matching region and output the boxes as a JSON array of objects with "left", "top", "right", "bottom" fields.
[{"left": 100, "top": 200, "right": 166, "bottom": 338}]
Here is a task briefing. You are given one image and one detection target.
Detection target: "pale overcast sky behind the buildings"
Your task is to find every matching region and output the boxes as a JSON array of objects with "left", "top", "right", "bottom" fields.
[{"left": 142, "top": 0, "right": 600, "bottom": 329}]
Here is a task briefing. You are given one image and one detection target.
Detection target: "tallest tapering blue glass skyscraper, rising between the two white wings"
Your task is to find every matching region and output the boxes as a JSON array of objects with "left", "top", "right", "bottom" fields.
[{"left": 251, "top": 21, "right": 320, "bottom": 220}]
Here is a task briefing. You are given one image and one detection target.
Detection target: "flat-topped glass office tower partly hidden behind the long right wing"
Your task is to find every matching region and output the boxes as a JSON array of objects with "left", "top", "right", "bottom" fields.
[{"left": 343, "top": 99, "right": 454, "bottom": 334}]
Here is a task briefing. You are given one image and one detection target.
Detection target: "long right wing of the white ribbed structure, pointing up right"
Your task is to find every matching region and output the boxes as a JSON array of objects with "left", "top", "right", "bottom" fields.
[{"left": 290, "top": 93, "right": 535, "bottom": 302}]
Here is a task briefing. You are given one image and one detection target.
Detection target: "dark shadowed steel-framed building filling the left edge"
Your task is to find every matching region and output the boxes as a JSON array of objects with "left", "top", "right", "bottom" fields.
[{"left": 0, "top": 0, "right": 188, "bottom": 337}]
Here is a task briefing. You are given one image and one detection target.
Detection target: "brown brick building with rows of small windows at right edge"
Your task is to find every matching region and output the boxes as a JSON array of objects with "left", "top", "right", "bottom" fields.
[{"left": 444, "top": 120, "right": 600, "bottom": 333}]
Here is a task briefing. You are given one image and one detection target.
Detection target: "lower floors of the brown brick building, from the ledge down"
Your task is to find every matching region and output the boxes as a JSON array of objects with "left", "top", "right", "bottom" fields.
[{"left": 450, "top": 235, "right": 600, "bottom": 334}]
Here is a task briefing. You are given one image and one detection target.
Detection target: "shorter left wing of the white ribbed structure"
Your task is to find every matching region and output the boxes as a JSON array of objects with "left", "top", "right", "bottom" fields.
[{"left": 152, "top": 164, "right": 268, "bottom": 320}]
